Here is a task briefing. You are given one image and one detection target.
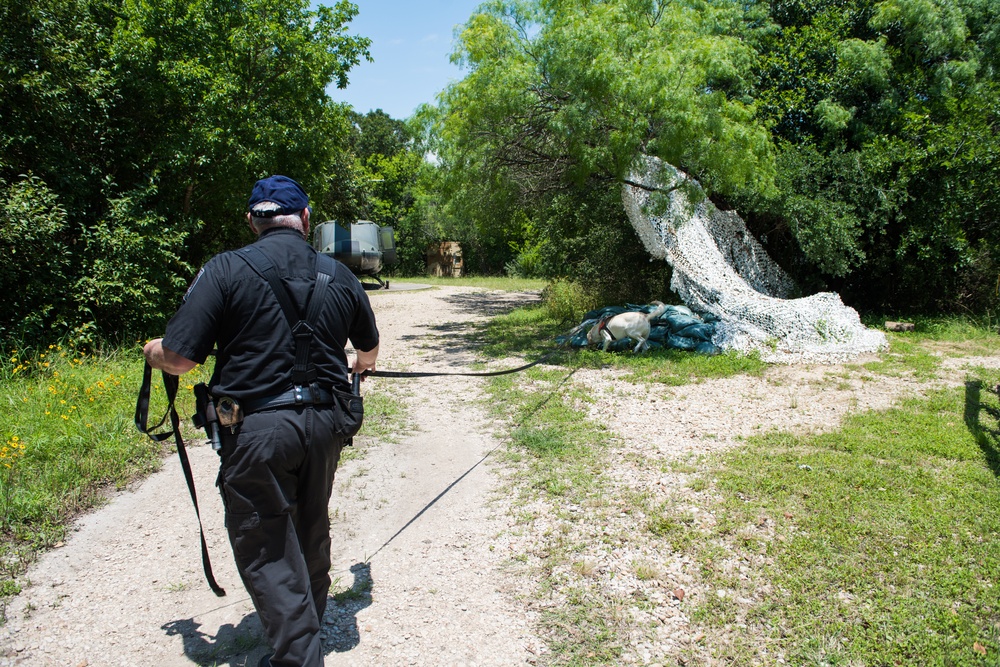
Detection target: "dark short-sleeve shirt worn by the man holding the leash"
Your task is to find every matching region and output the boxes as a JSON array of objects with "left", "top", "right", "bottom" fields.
[{"left": 163, "top": 227, "right": 379, "bottom": 399}]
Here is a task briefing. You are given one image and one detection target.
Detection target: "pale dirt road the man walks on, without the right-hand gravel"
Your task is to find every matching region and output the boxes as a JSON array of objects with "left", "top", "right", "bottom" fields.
[{"left": 0, "top": 287, "right": 541, "bottom": 667}]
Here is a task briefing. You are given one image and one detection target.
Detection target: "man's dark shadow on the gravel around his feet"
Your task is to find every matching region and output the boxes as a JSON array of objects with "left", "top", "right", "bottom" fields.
[{"left": 163, "top": 563, "right": 372, "bottom": 667}]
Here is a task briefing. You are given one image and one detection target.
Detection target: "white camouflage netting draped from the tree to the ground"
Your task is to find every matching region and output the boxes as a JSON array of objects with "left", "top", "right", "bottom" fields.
[{"left": 622, "top": 156, "right": 887, "bottom": 363}]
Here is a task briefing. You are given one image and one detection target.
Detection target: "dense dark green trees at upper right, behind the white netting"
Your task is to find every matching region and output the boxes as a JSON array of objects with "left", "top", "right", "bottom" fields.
[{"left": 737, "top": 0, "right": 1000, "bottom": 309}]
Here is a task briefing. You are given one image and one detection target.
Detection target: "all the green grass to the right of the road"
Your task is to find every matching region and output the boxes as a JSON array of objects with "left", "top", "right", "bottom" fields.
[{"left": 474, "top": 307, "right": 1000, "bottom": 666}]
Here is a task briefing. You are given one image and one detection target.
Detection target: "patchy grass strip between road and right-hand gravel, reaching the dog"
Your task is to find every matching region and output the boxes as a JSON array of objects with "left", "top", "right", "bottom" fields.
[{"left": 477, "top": 306, "right": 764, "bottom": 665}]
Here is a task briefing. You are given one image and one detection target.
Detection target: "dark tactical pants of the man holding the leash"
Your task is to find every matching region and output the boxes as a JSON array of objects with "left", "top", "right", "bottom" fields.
[{"left": 219, "top": 406, "right": 343, "bottom": 667}]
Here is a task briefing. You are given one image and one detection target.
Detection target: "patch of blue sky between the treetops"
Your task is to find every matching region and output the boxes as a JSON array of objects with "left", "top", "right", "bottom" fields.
[{"left": 328, "top": 0, "right": 482, "bottom": 119}]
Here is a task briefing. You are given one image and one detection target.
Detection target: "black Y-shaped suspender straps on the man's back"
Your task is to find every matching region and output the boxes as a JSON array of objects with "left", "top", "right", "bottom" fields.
[{"left": 236, "top": 245, "right": 337, "bottom": 386}]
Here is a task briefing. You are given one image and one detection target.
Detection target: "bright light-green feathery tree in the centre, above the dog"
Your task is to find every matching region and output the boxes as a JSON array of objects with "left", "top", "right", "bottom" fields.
[{"left": 428, "top": 0, "right": 774, "bottom": 292}]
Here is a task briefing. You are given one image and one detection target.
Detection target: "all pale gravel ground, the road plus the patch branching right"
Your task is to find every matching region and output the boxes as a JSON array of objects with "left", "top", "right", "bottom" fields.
[{"left": 0, "top": 287, "right": 1000, "bottom": 667}]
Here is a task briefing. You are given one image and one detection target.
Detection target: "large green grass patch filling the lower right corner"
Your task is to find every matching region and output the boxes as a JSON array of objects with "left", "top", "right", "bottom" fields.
[{"left": 693, "top": 371, "right": 1000, "bottom": 666}]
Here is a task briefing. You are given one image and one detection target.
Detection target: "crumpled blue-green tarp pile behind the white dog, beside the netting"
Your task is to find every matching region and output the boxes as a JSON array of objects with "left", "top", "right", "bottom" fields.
[{"left": 556, "top": 303, "right": 722, "bottom": 354}]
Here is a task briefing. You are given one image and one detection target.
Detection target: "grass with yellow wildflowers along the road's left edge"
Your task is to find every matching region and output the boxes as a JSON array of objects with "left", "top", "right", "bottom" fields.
[{"left": 0, "top": 346, "right": 166, "bottom": 595}]
